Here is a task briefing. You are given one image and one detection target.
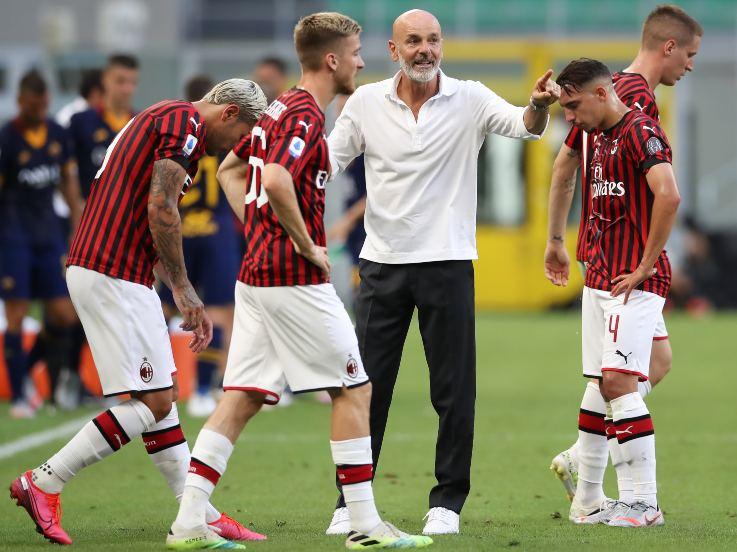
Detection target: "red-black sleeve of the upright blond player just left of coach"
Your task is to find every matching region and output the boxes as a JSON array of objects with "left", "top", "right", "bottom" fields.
[{"left": 264, "top": 111, "right": 323, "bottom": 178}]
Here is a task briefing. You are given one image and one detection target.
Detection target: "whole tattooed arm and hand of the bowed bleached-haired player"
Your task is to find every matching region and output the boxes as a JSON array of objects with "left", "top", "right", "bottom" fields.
[{"left": 148, "top": 159, "right": 212, "bottom": 353}]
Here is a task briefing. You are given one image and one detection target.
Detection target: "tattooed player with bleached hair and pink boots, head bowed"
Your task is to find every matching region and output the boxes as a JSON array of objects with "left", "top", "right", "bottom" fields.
[{"left": 11, "top": 79, "right": 266, "bottom": 544}]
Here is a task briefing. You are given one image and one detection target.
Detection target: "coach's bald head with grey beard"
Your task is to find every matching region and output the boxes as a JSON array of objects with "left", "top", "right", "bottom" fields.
[{"left": 389, "top": 10, "right": 443, "bottom": 83}]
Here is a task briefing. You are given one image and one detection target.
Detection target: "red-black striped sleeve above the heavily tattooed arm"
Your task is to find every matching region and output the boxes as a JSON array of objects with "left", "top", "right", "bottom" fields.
[{"left": 154, "top": 106, "right": 202, "bottom": 169}]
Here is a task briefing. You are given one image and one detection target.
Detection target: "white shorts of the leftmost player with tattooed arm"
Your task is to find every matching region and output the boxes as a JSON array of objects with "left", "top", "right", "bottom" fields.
[{"left": 67, "top": 266, "right": 176, "bottom": 397}]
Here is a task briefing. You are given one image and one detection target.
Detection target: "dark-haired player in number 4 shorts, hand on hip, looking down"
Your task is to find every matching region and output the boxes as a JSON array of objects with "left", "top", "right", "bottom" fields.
[{"left": 557, "top": 58, "right": 680, "bottom": 527}]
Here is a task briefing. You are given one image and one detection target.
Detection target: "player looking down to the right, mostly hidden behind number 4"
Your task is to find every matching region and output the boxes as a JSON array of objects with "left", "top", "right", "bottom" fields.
[{"left": 545, "top": 5, "right": 703, "bottom": 521}]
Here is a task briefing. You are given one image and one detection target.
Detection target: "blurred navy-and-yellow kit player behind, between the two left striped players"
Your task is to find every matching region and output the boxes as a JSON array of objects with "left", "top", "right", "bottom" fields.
[{"left": 159, "top": 75, "right": 240, "bottom": 418}]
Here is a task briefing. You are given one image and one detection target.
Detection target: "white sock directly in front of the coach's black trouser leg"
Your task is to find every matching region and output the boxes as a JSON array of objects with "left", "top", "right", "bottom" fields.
[{"left": 330, "top": 437, "right": 381, "bottom": 533}]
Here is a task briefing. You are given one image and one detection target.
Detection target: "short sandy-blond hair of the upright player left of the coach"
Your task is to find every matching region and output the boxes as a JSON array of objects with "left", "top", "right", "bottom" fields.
[{"left": 294, "top": 12, "right": 361, "bottom": 71}]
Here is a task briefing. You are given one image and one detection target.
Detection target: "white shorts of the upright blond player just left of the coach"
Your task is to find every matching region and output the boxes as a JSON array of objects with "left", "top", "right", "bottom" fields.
[{"left": 223, "top": 282, "right": 368, "bottom": 404}]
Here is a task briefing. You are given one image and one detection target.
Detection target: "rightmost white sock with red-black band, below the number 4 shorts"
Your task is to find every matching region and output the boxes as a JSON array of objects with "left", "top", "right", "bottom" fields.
[{"left": 612, "top": 393, "right": 658, "bottom": 507}]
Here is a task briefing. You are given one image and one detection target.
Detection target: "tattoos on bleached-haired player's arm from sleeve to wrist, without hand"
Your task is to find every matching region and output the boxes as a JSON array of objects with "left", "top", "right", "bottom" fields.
[{"left": 148, "top": 159, "right": 187, "bottom": 286}]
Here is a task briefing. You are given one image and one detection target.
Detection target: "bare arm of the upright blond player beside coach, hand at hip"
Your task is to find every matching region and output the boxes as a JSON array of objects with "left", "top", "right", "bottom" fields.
[{"left": 261, "top": 163, "right": 330, "bottom": 277}]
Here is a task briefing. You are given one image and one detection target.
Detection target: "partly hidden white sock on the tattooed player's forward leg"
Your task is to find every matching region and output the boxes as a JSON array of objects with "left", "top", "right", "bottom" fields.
[{"left": 141, "top": 404, "right": 220, "bottom": 523}]
